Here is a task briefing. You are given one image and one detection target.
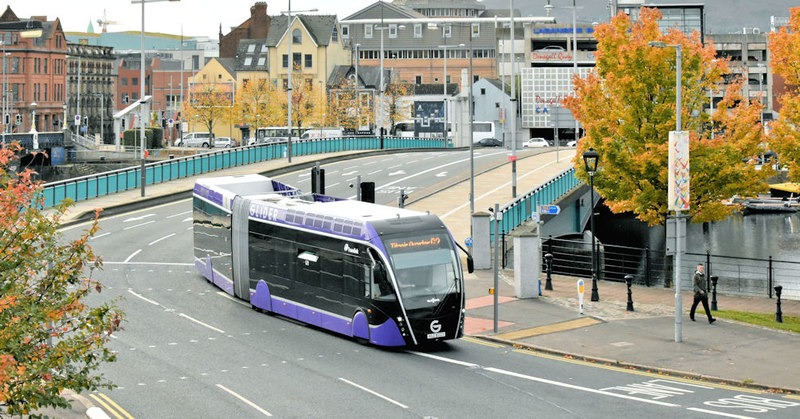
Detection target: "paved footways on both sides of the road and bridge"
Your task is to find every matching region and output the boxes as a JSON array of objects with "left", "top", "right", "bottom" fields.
[{"left": 42, "top": 149, "right": 800, "bottom": 418}]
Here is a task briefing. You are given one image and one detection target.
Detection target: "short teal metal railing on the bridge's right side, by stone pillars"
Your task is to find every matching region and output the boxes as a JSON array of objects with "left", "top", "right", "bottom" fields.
[{"left": 491, "top": 168, "right": 583, "bottom": 242}]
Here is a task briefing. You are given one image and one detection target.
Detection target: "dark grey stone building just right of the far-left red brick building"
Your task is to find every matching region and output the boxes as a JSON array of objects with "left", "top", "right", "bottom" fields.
[{"left": 66, "top": 43, "right": 117, "bottom": 143}]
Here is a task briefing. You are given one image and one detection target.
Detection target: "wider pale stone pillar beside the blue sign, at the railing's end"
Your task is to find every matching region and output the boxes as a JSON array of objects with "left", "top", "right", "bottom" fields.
[{"left": 513, "top": 229, "right": 542, "bottom": 298}]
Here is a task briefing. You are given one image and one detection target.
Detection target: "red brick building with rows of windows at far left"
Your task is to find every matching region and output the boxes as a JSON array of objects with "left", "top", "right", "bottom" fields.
[{"left": 0, "top": 7, "right": 67, "bottom": 132}]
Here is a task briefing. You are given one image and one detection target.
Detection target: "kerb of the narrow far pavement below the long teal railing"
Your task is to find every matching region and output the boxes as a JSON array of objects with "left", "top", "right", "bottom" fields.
[{"left": 60, "top": 147, "right": 463, "bottom": 228}]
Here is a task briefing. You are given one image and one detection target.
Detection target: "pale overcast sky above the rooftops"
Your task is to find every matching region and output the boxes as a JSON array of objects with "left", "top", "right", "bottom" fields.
[{"left": 0, "top": 0, "right": 800, "bottom": 39}]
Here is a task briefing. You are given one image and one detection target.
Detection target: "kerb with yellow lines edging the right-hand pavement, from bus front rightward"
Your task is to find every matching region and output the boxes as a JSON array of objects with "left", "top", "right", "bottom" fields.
[{"left": 470, "top": 335, "right": 800, "bottom": 395}]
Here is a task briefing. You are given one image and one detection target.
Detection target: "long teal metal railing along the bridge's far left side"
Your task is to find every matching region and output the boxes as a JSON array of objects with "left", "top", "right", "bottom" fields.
[{"left": 42, "top": 137, "right": 442, "bottom": 208}]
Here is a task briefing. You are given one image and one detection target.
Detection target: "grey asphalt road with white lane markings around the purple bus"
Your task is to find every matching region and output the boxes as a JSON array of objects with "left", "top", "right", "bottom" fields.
[{"left": 65, "top": 151, "right": 800, "bottom": 418}]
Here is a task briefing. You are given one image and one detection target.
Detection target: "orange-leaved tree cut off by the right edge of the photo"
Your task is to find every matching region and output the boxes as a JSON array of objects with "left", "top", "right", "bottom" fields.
[{"left": 769, "top": 7, "right": 800, "bottom": 182}]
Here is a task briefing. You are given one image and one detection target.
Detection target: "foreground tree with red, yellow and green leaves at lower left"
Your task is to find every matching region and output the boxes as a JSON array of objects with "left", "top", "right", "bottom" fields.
[{"left": 0, "top": 145, "right": 123, "bottom": 415}]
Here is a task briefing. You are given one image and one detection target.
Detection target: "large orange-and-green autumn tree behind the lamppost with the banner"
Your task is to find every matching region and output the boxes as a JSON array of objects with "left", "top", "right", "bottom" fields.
[{"left": 564, "top": 8, "right": 771, "bottom": 225}]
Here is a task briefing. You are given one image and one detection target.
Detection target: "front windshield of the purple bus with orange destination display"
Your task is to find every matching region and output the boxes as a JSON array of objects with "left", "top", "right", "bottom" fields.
[{"left": 384, "top": 232, "right": 460, "bottom": 309}]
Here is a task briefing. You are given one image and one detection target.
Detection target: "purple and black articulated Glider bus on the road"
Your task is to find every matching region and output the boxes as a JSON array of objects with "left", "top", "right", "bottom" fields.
[{"left": 193, "top": 175, "right": 472, "bottom": 346}]
